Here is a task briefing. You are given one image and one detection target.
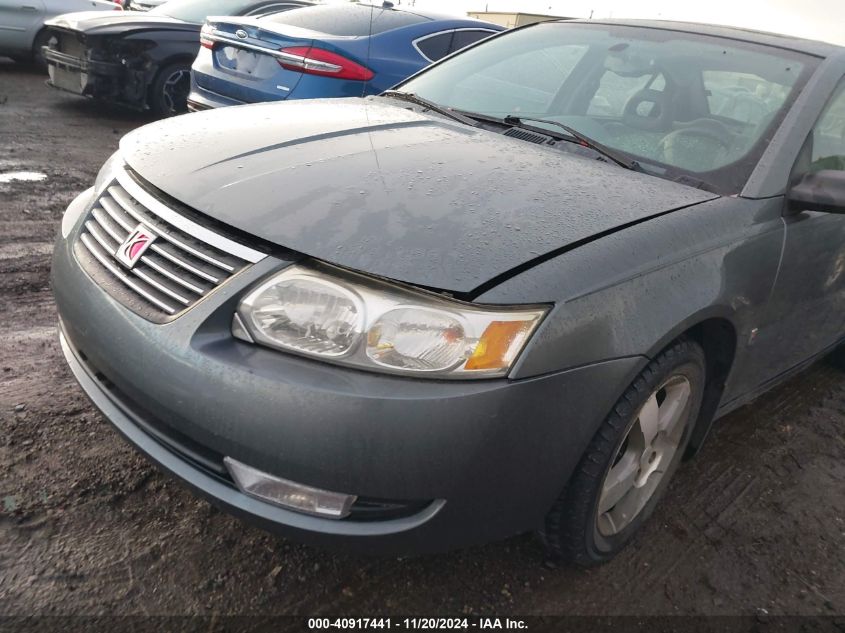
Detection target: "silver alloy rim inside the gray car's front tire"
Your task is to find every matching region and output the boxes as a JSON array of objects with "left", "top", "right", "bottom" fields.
[{"left": 596, "top": 375, "right": 692, "bottom": 537}]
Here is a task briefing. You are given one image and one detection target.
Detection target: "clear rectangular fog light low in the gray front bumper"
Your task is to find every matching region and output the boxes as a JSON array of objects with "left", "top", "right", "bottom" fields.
[{"left": 223, "top": 457, "right": 358, "bottom": 519}]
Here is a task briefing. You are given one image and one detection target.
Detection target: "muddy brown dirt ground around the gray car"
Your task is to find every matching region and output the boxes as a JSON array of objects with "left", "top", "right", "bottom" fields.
[{"left": 0, "top": 61, "right": 845, "bottom": 616}]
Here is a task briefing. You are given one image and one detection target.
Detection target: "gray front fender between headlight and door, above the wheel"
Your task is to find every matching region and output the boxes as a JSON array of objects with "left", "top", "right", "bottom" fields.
[{"left": 484, "top": 198, "right": 783, "bottom": 390}]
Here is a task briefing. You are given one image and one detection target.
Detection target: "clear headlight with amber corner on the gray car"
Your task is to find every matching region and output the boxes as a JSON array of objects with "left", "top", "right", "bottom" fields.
[{"left": 232, "top": 265, "right": 548, "bottom": 378}]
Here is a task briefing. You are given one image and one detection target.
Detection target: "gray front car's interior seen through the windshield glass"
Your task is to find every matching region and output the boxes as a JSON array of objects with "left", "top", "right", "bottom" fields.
[{"left": 428, "top": 29, "right": 804, "bottom": 188}]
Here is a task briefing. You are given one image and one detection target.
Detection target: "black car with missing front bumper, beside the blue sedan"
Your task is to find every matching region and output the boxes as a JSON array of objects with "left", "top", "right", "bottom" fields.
[{"left": 44, "top": 0, "right": 311, "bottom": 116}]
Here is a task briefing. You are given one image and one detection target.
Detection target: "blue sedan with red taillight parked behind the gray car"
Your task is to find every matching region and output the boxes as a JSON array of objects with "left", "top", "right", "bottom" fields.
[{"left": 188, "top": 3, "right": 503, "bottom": 110}]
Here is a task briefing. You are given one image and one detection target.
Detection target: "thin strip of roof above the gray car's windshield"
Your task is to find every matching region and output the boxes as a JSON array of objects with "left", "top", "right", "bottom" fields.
[{"left": 559, "top": 19, "right": 845, "bottom": 57}]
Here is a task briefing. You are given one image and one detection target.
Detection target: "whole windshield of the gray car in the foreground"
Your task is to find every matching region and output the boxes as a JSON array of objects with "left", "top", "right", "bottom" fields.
[{"left": 400, "top": 22, "right": 818, "bottom": 193}]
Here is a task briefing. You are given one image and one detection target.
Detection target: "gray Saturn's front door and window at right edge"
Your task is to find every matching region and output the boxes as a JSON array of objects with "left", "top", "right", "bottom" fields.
[{"left": 756, "top": 79, "right": 845, "bottom": 377}]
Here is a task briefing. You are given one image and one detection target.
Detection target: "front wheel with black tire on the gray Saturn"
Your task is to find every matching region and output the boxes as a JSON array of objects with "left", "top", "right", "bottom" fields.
[{"left": 540, "top": 339, "right": 706, "bottom": 567}]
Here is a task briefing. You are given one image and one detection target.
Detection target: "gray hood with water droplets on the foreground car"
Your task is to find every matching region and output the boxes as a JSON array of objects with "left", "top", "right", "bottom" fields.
[{"left": 120, "top": 97, "right": 716, "bottom": 293}]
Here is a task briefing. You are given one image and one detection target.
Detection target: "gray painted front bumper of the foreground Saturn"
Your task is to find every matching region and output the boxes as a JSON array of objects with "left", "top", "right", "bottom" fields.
[{"left": 52, "top": 189, "right": 643, "bottom": 554}]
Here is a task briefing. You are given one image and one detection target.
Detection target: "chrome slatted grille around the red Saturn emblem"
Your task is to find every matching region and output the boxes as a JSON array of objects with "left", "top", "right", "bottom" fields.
[{"left": 77, "top": 171, "right": 264, "bottom": 321}]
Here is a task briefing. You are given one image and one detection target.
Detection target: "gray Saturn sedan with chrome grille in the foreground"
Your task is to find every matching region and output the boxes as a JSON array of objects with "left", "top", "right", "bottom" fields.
[{"left": 53, "top": 21, "right": 845, "bottom": 564}]
